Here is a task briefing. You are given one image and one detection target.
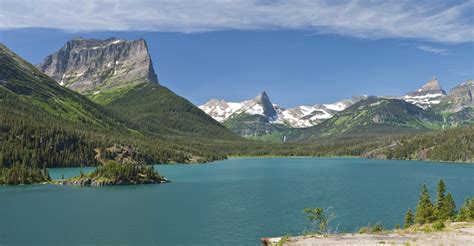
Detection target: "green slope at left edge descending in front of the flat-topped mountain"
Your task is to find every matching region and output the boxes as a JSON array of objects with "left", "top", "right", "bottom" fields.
[{"left": 0, "top": 44, "right": 125, "bottom": 129}]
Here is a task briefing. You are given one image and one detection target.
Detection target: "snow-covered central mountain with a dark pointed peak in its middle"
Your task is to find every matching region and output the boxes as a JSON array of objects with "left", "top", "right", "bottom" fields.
[{"left": 199, "top": 92, "right": 367, "bottom": 128}]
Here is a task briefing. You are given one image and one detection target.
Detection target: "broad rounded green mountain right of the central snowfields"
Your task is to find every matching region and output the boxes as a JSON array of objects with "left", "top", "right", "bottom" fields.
[{"left": 291, "top": 97, "right": 443, "bottom": 140}]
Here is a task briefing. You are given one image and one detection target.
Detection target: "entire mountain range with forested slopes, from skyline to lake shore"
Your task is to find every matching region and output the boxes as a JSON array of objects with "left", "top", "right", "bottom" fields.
[{"left": 0, "top": 38, "right": 474, "bottom": 167}]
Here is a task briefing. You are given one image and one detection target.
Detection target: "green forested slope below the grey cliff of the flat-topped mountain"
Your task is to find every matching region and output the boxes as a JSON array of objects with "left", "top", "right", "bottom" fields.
[{"left": 105, "top": 83, "right": 240, "bottom": 141}]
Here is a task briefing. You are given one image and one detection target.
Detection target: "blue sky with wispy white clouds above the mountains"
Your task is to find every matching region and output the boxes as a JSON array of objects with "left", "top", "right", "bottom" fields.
[{"left": 0, "top": 0, "right": 474, "bottom": 107}]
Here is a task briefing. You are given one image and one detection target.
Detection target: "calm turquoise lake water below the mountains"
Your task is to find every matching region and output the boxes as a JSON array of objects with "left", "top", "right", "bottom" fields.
[{"left": 0, "top": 158, "right": 474, "bottom": 246}]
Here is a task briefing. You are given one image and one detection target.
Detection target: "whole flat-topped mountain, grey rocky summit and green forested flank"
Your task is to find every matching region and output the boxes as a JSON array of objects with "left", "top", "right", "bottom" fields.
[{"left": 38, "top": 38, "right": 239, "bottom": 142}]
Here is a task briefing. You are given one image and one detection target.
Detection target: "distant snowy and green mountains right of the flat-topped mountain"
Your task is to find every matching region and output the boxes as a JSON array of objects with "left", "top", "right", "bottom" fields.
[{"left": 199, "top": 77, "right": 474, "bottom": 141}]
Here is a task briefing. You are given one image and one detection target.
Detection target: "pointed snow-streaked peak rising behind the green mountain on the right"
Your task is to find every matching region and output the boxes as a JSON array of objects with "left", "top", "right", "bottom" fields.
[{"left": 403, "top": 77, "right": 446, "bottom": 109}]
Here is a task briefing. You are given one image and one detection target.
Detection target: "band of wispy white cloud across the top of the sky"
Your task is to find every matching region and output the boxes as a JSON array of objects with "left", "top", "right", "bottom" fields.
[{"left": 0, "top": 0, "right": 474, "bottom": 43}]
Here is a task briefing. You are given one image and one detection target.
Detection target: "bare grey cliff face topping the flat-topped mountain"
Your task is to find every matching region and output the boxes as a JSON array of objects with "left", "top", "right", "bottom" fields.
[{"left": 37, "top": 38, "right": 158, "bottom": 94}]
